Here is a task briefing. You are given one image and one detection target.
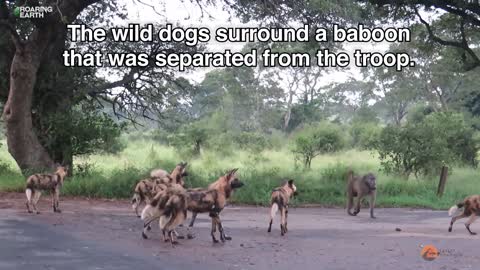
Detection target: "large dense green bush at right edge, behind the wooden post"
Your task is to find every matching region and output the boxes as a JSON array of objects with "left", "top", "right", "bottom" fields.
[{"left": 373, "top": 113, "right": 478, "bottom": 177}]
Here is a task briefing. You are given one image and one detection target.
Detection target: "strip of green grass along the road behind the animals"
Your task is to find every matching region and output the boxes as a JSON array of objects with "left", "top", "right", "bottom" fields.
[{"left": 0, "top": 137, "right": 480, "bottom": 209}]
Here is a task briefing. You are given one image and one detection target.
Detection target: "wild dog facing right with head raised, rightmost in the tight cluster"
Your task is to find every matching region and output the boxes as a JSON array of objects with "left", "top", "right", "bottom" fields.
[{"left": 187, "top": 169, "right": 243, "bottom": 243}]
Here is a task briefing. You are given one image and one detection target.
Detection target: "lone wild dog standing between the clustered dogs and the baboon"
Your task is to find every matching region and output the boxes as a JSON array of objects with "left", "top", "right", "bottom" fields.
[{"left": 268, "top": 179, "right": 297, "bottom": 236}]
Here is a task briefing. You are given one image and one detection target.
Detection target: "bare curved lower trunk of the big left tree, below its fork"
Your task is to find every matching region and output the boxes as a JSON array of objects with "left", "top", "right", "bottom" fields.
[{"left": 3, "top": 31, "right": 54, "bottom": 173}]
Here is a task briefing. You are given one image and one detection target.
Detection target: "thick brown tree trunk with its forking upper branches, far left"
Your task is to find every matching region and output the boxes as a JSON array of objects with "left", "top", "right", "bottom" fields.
[{"left": 1, "top": 0, "right": 98, "bottom": 173}]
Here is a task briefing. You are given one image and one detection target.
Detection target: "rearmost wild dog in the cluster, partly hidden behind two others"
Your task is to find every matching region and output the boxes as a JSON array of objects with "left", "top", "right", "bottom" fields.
[{"left": 132, "top": 162, "right": 188, "bottom": 217}]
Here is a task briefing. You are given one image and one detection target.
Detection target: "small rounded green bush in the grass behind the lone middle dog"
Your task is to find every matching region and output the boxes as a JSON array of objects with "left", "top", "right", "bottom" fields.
[{"left": 292, "top": 122, "right": 345, "bottom": 169}]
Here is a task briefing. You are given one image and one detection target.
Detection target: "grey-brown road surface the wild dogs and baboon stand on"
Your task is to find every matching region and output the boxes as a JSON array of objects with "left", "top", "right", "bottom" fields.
[{"left": 0, "top": 194, "right": 480, "bottom": 270}]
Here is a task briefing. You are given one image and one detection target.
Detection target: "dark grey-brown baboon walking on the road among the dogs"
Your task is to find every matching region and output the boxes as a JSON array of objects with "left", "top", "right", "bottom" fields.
[{"left": 347, "top": 170, "right": 377, "bottom": 218}]
